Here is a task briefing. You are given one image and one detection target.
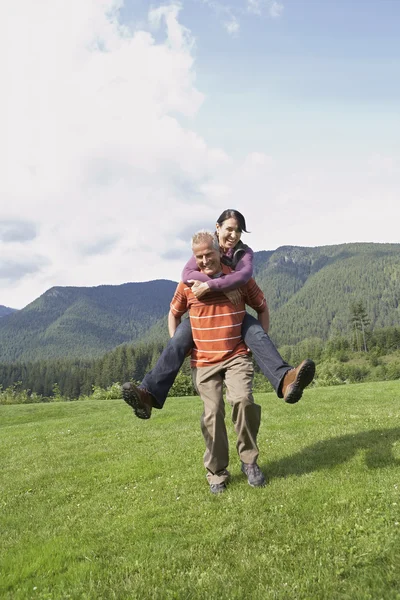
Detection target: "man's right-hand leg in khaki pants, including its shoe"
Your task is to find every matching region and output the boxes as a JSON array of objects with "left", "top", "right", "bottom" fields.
[{"left": 224, "top": 355, "right": 265, "bottom": 487}]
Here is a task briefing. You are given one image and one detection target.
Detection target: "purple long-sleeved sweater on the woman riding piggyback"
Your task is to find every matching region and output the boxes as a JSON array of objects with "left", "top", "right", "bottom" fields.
[{"left": 182, "top": 248, "right": 253, "bottom": 292}]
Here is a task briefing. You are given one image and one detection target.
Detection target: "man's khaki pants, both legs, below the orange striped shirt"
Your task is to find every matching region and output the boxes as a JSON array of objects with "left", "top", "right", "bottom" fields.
[{"left": 192, "top": 355, "right": 261, "bottom": 483}]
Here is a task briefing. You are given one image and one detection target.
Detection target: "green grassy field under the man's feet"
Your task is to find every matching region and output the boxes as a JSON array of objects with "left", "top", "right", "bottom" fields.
[{"left": 0, "top": 381, "right": 400, "bottom": 600}]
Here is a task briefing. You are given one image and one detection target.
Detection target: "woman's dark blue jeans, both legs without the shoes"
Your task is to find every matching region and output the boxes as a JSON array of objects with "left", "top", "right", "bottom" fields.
[{"left": 140, "top": 313, "right": 292, "bottom": 408}]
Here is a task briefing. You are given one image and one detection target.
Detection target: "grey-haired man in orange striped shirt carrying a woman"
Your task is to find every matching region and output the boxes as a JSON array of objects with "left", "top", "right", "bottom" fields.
[{"left": 168, "top": 231, "right": 269, "bottom": 494}]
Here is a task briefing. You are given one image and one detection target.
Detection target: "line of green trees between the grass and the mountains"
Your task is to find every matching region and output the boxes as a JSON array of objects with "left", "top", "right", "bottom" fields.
[{"left": 0, "top": 324, "right": 400, "bottom": 399}]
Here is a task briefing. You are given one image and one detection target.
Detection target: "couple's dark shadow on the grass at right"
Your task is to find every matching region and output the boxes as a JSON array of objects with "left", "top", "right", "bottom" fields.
[{"left": 263, "top": 427, "right": 400, "bottom": 479}]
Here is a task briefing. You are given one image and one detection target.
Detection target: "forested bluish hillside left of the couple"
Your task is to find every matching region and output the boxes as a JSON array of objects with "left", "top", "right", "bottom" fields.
[{"left": 0, "top": 280, "right": 176, "bottom": 362}]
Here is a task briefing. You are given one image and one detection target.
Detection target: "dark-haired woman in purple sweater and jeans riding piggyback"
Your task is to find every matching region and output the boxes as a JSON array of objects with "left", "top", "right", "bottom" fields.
[{"left": 123, "top": 209, "right": 315, "bottom": 419}]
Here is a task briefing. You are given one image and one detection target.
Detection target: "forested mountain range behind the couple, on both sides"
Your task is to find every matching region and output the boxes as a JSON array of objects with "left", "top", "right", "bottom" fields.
[{"left": 0, "top": 243, "right": 400, "bottom": 362}]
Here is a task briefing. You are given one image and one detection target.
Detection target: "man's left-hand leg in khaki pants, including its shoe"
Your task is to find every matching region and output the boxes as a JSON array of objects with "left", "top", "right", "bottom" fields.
[{"left": 192, "top": 364, "right": 229, "bottom": 493}]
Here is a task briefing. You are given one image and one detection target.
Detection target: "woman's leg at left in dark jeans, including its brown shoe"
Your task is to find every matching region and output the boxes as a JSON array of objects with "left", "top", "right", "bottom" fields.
[{"left": 122, "top": 319, "right": 193, "bottom": 419}]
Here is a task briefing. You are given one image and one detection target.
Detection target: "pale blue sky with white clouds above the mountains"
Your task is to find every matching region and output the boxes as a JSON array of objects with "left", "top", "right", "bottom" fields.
[{"left": 0, "top": 0, "right": 400, "bottom": 308}]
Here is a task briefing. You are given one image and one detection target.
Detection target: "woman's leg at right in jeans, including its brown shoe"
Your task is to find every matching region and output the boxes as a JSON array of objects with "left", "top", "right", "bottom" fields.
[{"left": 242, "top": 313, "right": 315, "bottom": 404}]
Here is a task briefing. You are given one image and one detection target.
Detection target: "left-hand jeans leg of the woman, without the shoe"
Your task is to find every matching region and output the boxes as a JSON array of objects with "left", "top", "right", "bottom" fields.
[{"left": 139, "top": 319, "right": 193, "bottom": 408}]
